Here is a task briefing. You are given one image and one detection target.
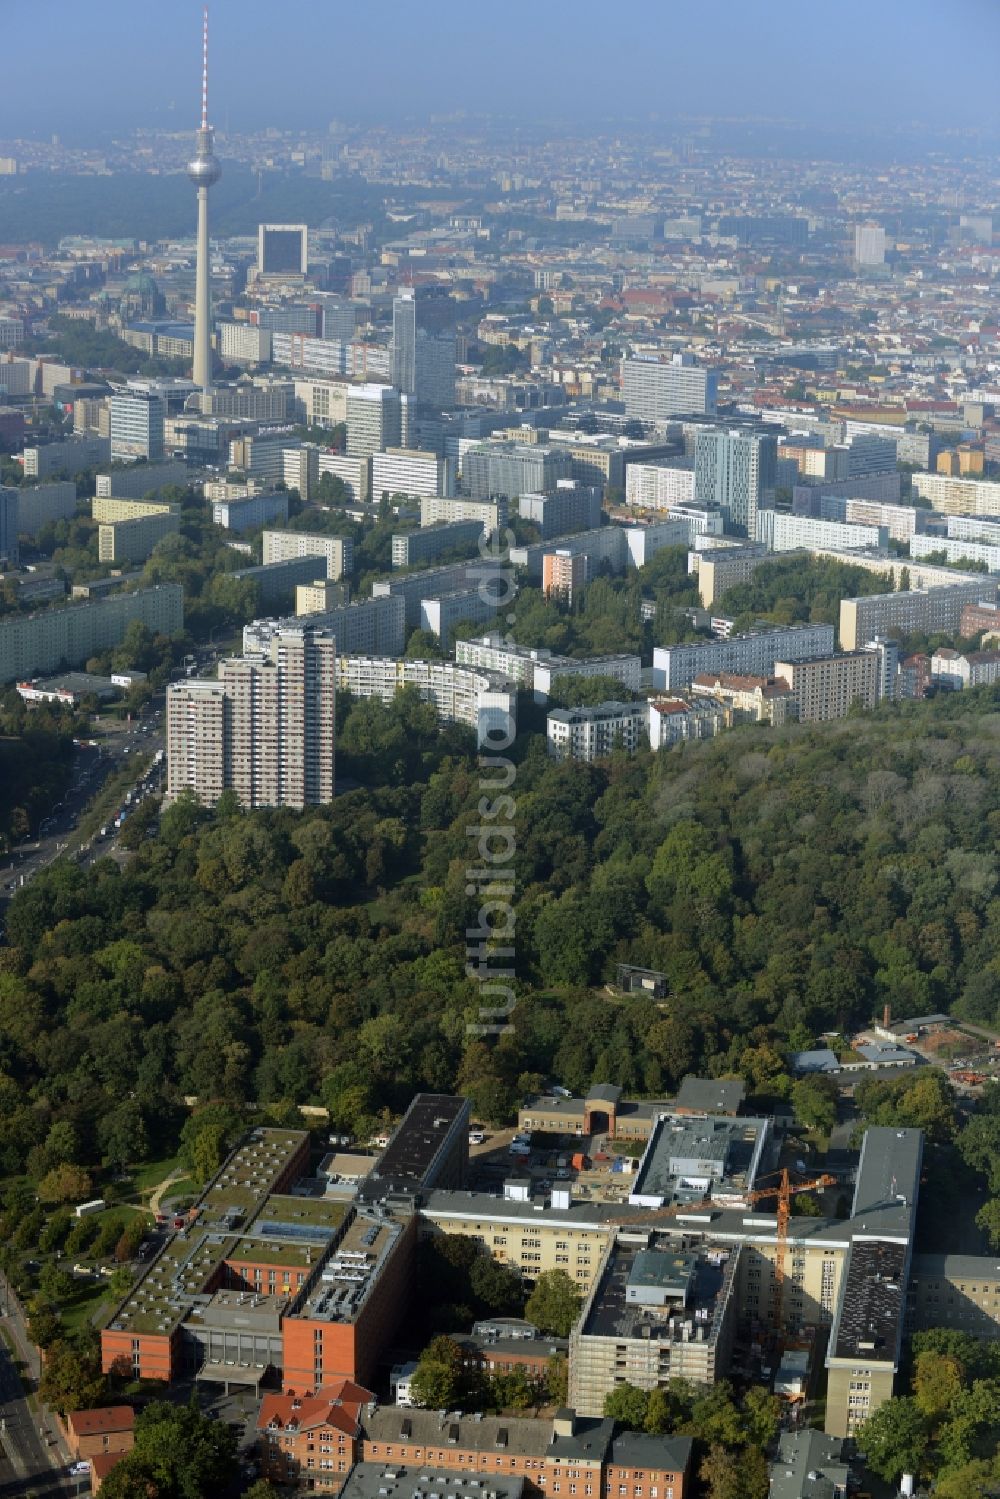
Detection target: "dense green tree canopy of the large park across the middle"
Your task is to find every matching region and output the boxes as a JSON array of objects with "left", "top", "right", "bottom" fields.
[{"left": 0, "top": 690, "right": 1000, "bottom": 1193}]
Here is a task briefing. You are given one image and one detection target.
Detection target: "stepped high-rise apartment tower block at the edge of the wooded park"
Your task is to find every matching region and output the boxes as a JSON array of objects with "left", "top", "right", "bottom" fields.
[{"left": 166, "top": 625, "right": 336, "bottom": 808}]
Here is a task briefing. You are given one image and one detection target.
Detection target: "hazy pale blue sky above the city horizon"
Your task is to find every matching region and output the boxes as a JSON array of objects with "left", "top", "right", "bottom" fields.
[{"left": 0, "top": 0, "right": 1000, "bottom": 138}]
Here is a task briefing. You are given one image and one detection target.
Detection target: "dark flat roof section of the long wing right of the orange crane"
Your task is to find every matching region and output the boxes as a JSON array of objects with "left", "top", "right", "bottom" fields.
[{"left": 831, "top": 1240, "right": 907, "bottom": 1367}]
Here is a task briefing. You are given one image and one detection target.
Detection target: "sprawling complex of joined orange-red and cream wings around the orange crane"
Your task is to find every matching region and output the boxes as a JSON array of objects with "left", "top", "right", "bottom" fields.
[{"left": 102, "top": 1079, "right": 971, "bottom": 1462}]
